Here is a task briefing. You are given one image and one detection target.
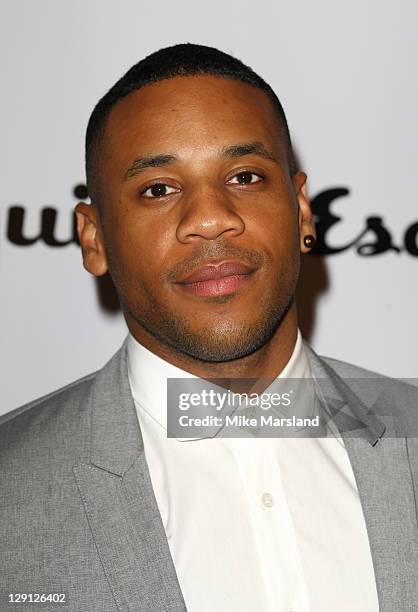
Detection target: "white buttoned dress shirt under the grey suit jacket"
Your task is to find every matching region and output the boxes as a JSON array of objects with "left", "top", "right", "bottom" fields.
[{"left": 128, "top": 332, "right": 379, "bottom": 612}]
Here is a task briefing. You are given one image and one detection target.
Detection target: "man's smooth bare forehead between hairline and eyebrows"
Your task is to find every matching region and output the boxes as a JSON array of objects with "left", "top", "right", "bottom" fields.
[{"left": 103, "top": 75, "right": 285, "bottom": 163}]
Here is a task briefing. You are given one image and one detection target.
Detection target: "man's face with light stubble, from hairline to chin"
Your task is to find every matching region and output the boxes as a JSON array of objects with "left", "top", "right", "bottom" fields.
[{"left": 83, "top": 75, "right": 307, "bottom": 361}]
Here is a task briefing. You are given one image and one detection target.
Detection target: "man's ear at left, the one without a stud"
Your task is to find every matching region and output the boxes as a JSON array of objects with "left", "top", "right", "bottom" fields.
[{"left": 75, "top": 202, "right": 108, "bottom": 276}]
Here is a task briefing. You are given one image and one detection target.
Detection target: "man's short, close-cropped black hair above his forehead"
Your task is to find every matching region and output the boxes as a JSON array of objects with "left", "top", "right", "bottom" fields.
[{"left": 86, "top": 43, "right": 296, "bottom": 203}]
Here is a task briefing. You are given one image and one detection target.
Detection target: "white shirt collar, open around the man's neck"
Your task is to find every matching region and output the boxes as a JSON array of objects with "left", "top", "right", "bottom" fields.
[{"left": 127, "top": 330, "right": 311, "bottom": 429}]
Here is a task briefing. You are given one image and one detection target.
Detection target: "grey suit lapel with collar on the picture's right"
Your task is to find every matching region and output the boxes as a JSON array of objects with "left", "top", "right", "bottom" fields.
[{"left": 308, "top": 348, "right": 418, "bottom": 612}]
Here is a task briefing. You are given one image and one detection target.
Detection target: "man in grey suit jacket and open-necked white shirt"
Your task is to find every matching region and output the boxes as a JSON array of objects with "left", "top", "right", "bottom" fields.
[{"left": 0, "top": 45, "right": 418, "bottom": 612}]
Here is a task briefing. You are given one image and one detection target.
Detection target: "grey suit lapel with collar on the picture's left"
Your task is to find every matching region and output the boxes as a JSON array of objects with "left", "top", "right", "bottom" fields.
[{"left": 74, "top": 345, "right": 186, "bottom": 612}]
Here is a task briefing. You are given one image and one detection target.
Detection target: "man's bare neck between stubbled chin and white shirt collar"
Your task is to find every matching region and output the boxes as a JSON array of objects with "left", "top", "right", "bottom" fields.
[{"left": 126, "top": 304, "right": 297, "bottom": 392}]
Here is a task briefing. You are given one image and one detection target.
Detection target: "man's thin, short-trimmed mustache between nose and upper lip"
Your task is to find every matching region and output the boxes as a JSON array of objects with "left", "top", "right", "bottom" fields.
[{"left": 163, "top": 241, "right": 266, "bottom": 283}]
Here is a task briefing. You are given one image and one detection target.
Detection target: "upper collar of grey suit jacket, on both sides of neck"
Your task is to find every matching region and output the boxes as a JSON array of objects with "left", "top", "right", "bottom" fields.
[{"left": 91, "top": 341, "right": 386, "bottom": 476}]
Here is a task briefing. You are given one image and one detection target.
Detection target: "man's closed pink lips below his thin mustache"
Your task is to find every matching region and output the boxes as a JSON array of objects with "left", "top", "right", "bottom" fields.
[{"left": 177, "top": 261, "right": 255, "bottom": 297}]
